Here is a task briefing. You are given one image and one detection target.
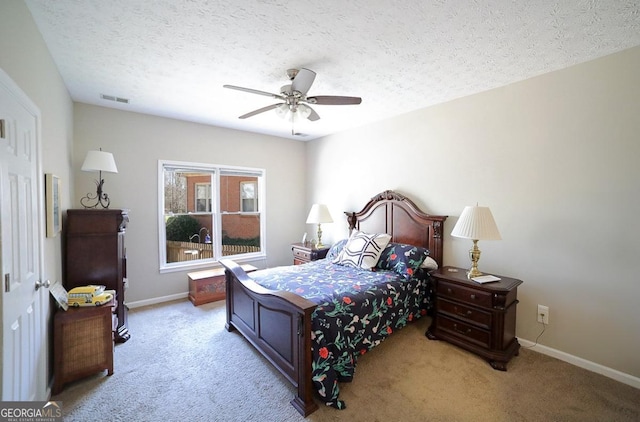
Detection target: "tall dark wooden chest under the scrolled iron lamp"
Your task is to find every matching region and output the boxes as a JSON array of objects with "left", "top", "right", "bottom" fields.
[{"left": 63, "top": 209, "right": 130, "bottom": 343}]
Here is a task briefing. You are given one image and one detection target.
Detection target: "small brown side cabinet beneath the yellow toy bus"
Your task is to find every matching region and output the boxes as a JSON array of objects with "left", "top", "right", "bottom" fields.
[{"left": 51, "top": 299, "right": 117, "bottom": 394}]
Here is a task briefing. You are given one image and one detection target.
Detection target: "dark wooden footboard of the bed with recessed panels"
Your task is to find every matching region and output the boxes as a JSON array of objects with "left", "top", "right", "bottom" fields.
[{"left": 220, "top": 259, "right": 318, "bottom": 416}]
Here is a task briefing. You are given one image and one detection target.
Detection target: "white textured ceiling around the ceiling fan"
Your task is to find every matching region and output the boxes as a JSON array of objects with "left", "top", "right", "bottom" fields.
[{"left": 25, "top": 0, "right": 640, "bottom": 140}]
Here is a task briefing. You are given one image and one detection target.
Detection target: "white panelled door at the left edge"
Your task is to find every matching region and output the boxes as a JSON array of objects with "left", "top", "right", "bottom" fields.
[{"left": 0, "top": 69, "right": 49, "bottom": 401}]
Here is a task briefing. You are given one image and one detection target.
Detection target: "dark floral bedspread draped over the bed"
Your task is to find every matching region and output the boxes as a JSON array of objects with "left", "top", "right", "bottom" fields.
[{"left": 251, "top": 259, "right": 431, "bottom": 409}]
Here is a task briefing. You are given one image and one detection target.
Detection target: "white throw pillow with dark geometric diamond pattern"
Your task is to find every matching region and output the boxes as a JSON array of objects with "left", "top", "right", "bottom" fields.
[{"left": 332, "top": 230, "right": 391, "bottom": 270}]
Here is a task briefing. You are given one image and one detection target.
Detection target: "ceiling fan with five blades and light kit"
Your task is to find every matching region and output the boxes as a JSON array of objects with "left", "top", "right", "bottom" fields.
[{"left": 223, "top": 68, "right": 362, "bottom": 129}]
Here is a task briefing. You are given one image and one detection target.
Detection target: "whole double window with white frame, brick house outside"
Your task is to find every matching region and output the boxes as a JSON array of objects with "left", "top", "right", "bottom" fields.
[{"left": 158, "top": 160, "right": 265, "bottom": 271}]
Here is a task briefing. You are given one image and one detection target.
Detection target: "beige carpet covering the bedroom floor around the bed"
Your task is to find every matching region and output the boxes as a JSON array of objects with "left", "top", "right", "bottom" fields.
[{"left": 52, "top": 300, "right": 640, "bottom": 422}]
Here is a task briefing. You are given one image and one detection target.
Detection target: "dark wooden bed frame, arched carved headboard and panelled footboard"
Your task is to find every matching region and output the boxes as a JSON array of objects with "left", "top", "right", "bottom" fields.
[{"left": 220, "top": 190, "right": 447, "bottom": 416}]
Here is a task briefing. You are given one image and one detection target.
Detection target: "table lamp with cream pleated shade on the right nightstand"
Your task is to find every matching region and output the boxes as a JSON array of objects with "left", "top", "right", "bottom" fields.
[{"left": 451, "top": 205, "right": 502, "bottom": 278}]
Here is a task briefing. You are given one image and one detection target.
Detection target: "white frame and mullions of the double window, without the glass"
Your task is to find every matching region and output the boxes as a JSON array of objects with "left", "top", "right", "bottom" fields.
[{"left": 158, "top": 160, "right": 267, "bottom": 273}]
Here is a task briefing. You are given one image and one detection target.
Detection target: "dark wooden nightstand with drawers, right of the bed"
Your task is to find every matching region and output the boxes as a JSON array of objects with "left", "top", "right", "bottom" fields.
[{"left": 426, "top": 267, "right": 522, "bottom": 371}]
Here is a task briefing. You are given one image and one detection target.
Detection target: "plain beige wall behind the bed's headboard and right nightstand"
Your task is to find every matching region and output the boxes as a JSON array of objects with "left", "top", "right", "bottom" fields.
[{"left": 307, "top": 47, "right": 640, "bottom": 377}]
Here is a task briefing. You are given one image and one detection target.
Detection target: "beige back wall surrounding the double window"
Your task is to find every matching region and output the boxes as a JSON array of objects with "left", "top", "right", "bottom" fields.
[{"left": 73, "top": 103, "right": 306, "bottom": 302}]
